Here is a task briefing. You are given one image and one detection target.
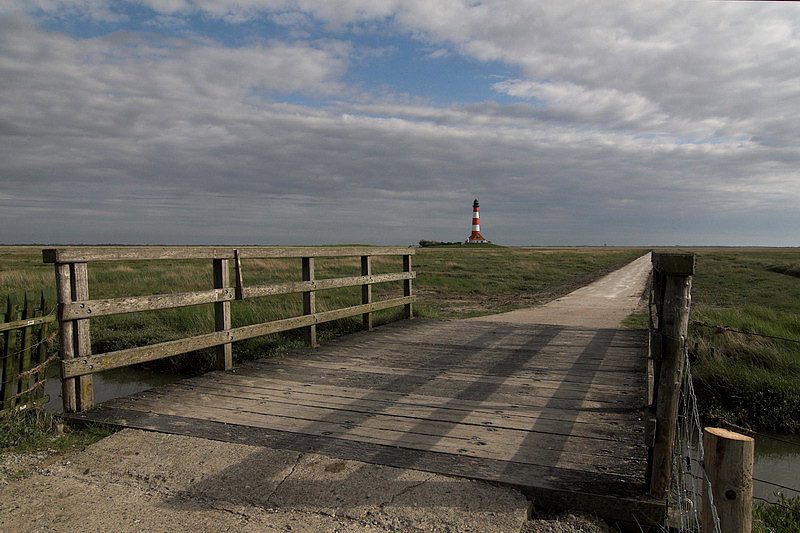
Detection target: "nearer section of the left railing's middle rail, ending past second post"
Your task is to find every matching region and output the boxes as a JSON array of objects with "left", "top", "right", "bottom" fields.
[{"left": 59, "top": 287, "right": 235, "bottom": 320}]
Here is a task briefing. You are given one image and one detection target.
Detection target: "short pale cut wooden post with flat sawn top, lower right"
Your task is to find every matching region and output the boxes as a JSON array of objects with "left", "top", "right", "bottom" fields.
[{"left": 703, "top": 428, "right": 755, "bottom": 533}]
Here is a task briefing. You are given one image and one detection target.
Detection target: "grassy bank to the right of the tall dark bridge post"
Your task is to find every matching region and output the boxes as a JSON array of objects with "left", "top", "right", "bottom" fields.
[{"left": 690, "top": 249, "right": 800, "bottom": 433}]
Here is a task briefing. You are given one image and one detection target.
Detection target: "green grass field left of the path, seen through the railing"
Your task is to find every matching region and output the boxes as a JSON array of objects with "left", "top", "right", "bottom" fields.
[{"left": 0, "top": 246, "right": 644, "bottom": 373}]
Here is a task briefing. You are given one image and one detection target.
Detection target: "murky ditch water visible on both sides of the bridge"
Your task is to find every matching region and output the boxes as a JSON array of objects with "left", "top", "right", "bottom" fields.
[{"left": 45, "top": 365, "right": 800, "bottom": 502}]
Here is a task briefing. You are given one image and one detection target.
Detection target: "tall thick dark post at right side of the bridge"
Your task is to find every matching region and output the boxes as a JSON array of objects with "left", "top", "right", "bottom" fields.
[{"left": 648, "top": 253, "right": 694, "bottom": 499}]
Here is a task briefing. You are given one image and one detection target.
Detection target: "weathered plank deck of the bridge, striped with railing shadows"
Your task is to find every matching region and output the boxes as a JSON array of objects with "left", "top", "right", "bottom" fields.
[{"left": 64, "top": 320, "right": 664, "bottom": 523}]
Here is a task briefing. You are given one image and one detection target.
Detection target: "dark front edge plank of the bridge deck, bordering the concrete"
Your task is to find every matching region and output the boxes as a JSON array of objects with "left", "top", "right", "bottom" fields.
[{"left": 61, "top": 407, "right": 665, "bottom": 524}]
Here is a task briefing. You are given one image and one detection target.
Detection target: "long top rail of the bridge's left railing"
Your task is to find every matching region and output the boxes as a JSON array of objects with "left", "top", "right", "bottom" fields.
[{"left": 42, "top": 246, "right": 415, "bottom": 263}]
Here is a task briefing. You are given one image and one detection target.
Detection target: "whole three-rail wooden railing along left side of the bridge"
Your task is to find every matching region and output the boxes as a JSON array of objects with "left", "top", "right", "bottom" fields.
[{"left": 42, "top": 247, "right": 416, "bottom": 412}]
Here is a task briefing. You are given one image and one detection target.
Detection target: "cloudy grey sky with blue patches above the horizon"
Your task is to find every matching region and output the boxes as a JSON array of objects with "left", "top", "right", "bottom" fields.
[{"left": 0, "top": 0, "right": 800, "bottom": 246}]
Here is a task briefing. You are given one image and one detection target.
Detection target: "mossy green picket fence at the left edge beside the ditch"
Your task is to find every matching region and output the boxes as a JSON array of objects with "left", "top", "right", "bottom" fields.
[{"left": 0, "top": 289, "right": 56, "bottom": 413}]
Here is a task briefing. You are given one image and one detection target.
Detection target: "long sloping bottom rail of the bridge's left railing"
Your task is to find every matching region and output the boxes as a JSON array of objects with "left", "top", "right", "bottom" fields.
[{"left": 61, "top": 296, "right": 415, "bottom": 378}]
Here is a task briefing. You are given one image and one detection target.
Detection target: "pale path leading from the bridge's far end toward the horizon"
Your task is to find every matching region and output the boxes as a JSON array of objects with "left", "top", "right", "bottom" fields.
[{"left": 471, "top": 253, "right": 651, "bottom": 328}]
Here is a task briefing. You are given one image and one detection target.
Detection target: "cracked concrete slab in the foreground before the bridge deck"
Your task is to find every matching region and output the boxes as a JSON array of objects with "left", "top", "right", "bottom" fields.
[{"left": 0, "top": 429, "right": 529, "bottom": 532}]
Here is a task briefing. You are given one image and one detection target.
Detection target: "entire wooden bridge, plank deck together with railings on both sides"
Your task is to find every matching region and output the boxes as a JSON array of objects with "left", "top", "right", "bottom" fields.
[{"left": 45, "top": 248, "right": 693, "bottom": 526}]
